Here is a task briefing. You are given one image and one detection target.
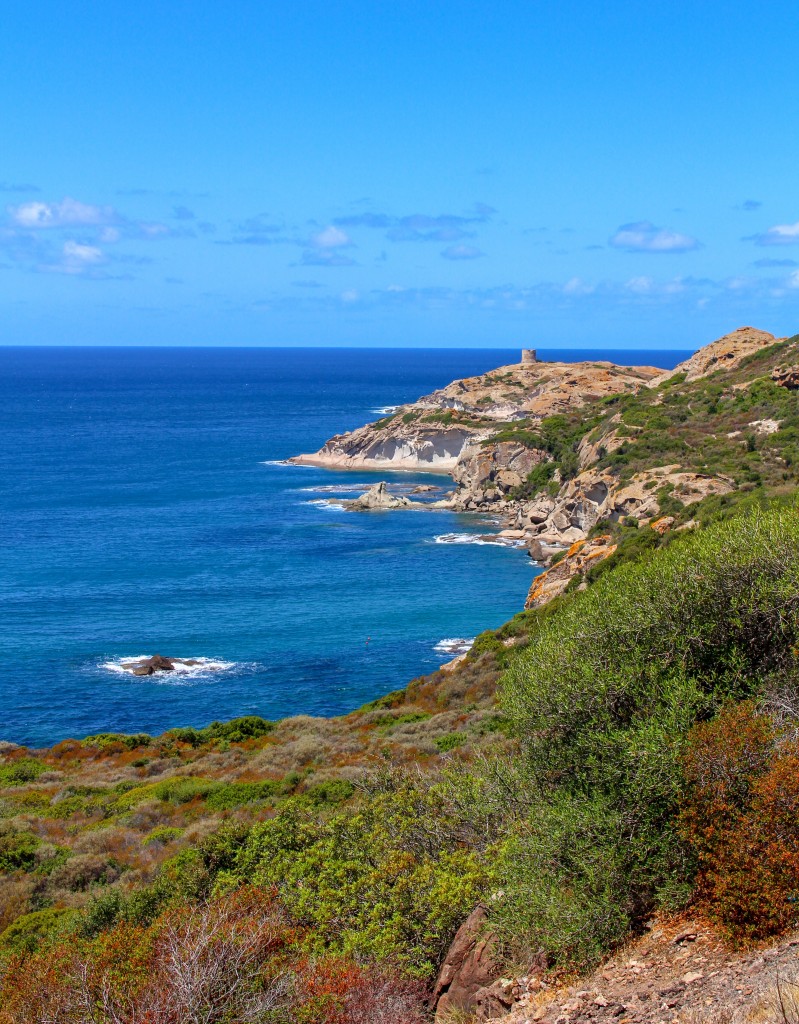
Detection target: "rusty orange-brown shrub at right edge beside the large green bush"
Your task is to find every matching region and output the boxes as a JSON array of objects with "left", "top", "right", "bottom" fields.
[{"left": 680, "top": 702, "right": 799, "bottom": 940}]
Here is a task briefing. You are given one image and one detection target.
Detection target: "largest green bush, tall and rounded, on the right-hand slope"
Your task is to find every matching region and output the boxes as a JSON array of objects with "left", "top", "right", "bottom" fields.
[{"left": 501, "top": 510, "right": 799, "bottom": 958}]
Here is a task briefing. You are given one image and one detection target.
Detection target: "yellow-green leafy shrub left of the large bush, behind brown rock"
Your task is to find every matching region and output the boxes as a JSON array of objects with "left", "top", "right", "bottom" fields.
[{"left": 235, "top": 783, "right": 487, "bottom": 976}]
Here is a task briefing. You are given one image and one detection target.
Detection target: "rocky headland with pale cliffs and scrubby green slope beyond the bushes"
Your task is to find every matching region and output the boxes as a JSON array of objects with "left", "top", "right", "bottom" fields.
[{"left": 293, "top": 327, "right": 799, "bottom": 606}]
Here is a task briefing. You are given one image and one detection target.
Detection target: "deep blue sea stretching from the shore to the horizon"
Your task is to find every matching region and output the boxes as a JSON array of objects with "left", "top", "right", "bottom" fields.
[{"left": 0, "top": 348, "right": 687, "bottom": 745}]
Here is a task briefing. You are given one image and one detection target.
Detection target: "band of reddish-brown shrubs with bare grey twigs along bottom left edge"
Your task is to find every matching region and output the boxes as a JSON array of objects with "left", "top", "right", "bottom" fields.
[{"left": 0, "top": 888, "right": 425, "bottom": 1024}]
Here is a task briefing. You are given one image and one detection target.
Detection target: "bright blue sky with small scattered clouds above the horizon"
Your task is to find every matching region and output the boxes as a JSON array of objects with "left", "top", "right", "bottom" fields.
[{"left": 0, "top": 0, "right": 799, "bottom": 348}]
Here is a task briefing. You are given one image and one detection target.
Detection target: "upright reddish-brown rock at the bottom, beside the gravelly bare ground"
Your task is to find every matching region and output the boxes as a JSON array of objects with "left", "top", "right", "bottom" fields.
[{"left": 431, "top": 906, "right": 499, "bottom": 1024}]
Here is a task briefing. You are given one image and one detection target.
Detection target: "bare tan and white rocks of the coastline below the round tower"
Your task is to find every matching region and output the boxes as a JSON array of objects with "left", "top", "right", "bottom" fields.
[{"left": 289, "top": 327, "right": 795, "bottom": 607}]
